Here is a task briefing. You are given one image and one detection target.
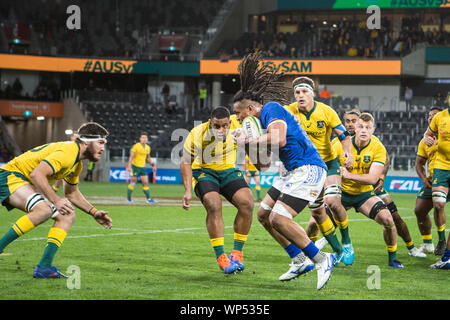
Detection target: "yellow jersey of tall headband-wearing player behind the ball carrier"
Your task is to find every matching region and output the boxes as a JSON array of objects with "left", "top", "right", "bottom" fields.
[{"left": 284, "top": 101, "right": 341, "bottom": 162}]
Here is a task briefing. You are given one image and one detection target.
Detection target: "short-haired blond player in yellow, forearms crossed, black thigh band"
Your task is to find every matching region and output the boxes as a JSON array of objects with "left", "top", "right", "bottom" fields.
[{"left": 336, "top": 113, "right": 403, "bottom": 268}]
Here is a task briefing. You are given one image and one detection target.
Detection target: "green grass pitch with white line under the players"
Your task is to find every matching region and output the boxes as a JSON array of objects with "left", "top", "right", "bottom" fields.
[{"left": 0, "top": 183, "right": 450, "bottom": 300}]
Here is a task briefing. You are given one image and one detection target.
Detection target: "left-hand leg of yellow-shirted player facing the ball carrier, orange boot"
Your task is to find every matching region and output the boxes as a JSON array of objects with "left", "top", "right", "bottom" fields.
[{"left": 194, "top": 180, "right": 238, "bottom": 273}]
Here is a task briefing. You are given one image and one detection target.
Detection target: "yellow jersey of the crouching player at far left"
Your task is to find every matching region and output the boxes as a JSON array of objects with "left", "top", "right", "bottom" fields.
[{"left": 1, "top": 141, "right": 83, "bottom": 184}]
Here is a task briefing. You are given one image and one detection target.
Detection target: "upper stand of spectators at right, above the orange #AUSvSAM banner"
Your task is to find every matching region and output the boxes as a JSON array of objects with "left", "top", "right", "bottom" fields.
[{"left": 218, "top": 16, "right": 450, "bottom": 58}]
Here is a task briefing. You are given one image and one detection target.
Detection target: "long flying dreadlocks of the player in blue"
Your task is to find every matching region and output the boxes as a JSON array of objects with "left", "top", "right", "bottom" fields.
[{"left": 233, "top": 52, "right": 291, "bottom": 105}]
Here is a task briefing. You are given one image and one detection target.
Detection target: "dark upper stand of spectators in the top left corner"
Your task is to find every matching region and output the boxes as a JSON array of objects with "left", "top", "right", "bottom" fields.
[{"left": 0, "top": 0, "right": 222, "bottom": 59}]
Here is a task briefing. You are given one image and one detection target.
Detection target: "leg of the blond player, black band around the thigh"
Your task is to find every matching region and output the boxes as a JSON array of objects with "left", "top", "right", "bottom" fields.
[{"left": 358, "top": 197, "right": 403, "bottom": 268}]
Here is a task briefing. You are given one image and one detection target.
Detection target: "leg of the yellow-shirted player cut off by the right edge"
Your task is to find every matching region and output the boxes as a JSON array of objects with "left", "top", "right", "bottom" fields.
[{"left": 431, "top": 169, "right": 450, "bottom": 255}]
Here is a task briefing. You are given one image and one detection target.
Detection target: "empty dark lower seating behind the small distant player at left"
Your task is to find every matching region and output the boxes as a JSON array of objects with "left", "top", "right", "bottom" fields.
[{"left": 77, "top": 90, "right": 188, "bottom": 158}]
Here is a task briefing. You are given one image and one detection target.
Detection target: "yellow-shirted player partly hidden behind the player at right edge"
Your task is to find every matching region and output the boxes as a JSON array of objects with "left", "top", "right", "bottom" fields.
[{"left": 414, "top": 107, "right": 449, "bottom": 253}]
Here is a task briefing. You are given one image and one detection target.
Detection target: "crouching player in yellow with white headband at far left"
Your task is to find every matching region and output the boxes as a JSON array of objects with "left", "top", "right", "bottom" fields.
[{"left": 0, "top": 122, "right": 112, "bottom": 278}]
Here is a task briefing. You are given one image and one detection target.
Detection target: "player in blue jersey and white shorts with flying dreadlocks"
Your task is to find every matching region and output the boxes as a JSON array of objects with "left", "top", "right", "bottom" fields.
[{"left": 233, "top": 53, "right": 335, "bottom": 290}]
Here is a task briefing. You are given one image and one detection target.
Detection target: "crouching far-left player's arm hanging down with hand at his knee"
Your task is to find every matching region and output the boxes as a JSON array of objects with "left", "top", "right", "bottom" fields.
[{"left": 30, "top": 161, "right": 75, "bottom": 214}]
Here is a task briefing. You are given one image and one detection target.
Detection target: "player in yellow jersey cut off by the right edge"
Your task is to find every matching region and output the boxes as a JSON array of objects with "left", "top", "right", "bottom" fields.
[{"left": 423, "top": 106, "right": 450, "bottom": 269}]
